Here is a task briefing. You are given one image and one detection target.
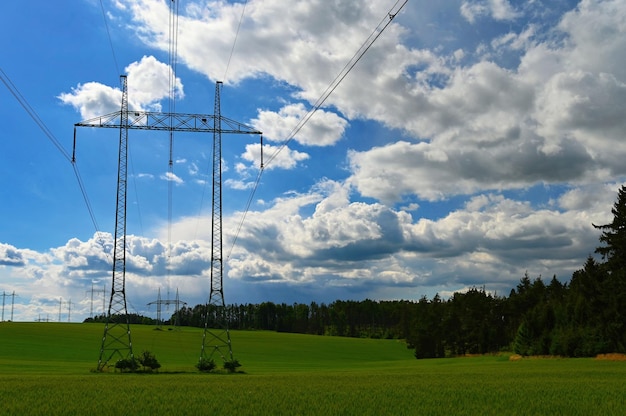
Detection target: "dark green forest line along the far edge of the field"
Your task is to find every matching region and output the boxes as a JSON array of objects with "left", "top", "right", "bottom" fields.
[{"left": 86, "top": 187, "right": 626, "bottom": 358}]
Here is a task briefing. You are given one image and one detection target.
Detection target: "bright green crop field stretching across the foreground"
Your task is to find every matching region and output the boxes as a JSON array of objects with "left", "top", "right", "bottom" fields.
[{"left": 0, "top": 322, "right": 626, "bottom": 415}]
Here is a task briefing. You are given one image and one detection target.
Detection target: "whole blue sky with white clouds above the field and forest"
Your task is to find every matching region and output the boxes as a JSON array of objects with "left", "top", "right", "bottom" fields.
[{"left": 0, "top": 0, "right": 626, "bottom": 321}]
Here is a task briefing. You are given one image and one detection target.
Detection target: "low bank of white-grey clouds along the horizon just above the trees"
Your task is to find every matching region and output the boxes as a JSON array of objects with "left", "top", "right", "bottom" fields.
[{"left": 0, "top": 177, "right": 618, "bottom": 319}]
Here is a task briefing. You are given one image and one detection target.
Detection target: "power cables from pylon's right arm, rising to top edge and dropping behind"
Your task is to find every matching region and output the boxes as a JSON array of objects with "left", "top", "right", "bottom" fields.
[{"left": 226, "top": 0, "right": 408, "bottom": 258}]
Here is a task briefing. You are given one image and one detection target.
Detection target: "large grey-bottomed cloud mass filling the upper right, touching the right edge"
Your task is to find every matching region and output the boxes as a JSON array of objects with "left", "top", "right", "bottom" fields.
[{"left": 342, "top": 1, "right": 626, "bottom": 203}]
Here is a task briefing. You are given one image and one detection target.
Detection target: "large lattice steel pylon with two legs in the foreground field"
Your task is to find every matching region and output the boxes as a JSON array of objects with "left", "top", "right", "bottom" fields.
[{"left": 72, "top": 75, "right": 262, "bottom": 371}]
